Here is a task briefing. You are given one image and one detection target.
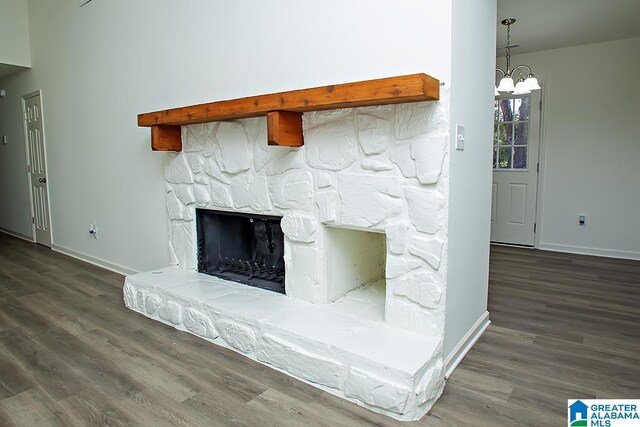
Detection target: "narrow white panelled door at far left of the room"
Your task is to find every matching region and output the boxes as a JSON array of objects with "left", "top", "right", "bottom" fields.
[{"left": 23, "top": 93, "right": 51, "bottom": 247}]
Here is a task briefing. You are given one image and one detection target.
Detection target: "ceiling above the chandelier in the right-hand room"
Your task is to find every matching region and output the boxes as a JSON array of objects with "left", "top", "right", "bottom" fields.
[{"left": 496, "top": 0, "right": 640, "bottom": 56}]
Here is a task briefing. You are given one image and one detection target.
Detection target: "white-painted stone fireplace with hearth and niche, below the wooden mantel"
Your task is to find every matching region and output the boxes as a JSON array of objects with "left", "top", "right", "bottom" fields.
[{"left": 124, "top": 91, "right": 449, "bottom": 420}]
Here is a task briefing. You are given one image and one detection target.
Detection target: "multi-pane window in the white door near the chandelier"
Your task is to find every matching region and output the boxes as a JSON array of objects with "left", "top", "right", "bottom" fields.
[{"left": 493, "top": 95, "right": 531, "bottom": 170}]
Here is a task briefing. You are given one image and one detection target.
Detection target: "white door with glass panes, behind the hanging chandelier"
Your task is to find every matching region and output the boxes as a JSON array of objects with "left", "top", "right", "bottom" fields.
[{"left": 491, "top": 90, "right": 542, "bottom": 246}]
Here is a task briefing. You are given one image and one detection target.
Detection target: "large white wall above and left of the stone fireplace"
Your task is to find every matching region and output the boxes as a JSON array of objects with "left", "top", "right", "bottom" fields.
[{"left": 0, "top": 0, "right": 451, "bottom": 271}]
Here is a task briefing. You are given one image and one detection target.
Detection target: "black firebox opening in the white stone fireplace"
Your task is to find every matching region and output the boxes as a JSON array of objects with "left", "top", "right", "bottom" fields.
[{"left": 196, "top": 209, "right": 285, "bottom": 294}]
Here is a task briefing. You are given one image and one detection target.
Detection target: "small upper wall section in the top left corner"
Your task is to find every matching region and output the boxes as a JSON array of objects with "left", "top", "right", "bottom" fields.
[{"left": 0, "top": 0, "right": 31, "bottom": 67}]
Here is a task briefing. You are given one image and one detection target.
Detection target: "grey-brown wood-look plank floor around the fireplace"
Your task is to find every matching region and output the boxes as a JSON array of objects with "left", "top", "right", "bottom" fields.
[{"left": 0, "top": 234, "right": 640, "bottom": 427}]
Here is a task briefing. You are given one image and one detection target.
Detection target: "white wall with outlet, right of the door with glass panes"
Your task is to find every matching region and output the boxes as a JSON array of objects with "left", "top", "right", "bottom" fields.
[{"left": 500, "top": 38, "right": 640, "bottom": 259}]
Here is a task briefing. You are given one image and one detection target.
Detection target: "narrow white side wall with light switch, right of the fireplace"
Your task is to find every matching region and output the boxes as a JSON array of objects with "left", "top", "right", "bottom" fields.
[{"left": 444, "top": 0, "right": 496, "bottom": 358}]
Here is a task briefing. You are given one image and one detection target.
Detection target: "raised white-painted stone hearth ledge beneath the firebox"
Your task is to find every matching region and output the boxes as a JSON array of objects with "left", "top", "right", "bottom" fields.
[{"left": 124, "top": 267, "right": 444, "bottom": 421}]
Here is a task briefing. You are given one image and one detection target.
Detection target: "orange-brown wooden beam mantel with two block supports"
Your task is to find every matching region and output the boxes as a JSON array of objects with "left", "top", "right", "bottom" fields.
[{"left": 138, "top": 73, "right": 440, "bottom": 151}]
